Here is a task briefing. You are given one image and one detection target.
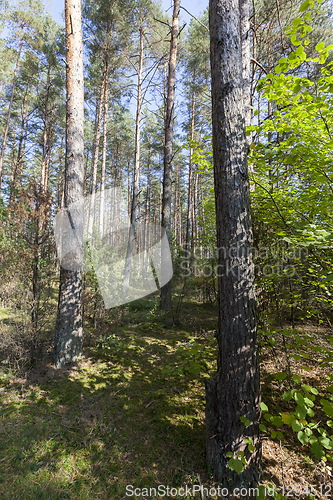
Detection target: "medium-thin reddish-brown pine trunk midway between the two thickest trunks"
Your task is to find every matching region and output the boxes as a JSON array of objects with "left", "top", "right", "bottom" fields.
[{"left": 160, "top": 0, "right": 180, "bottom": 309}]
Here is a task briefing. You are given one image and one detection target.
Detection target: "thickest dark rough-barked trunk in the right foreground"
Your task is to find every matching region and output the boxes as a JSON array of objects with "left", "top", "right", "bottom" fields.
[{"left": 206, "top": 0, "right": 261, "bottom": 492}]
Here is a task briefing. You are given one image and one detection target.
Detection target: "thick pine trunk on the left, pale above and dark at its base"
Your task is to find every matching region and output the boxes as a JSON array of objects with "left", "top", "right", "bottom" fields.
[{"left": 54, "top": 0, "right": 84, "bottom": 367}]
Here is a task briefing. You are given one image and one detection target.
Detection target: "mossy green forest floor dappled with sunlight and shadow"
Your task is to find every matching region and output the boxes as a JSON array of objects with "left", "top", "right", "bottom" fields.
[{"left": 0, "top": 297, "right": 333, "bottom": 500}]
